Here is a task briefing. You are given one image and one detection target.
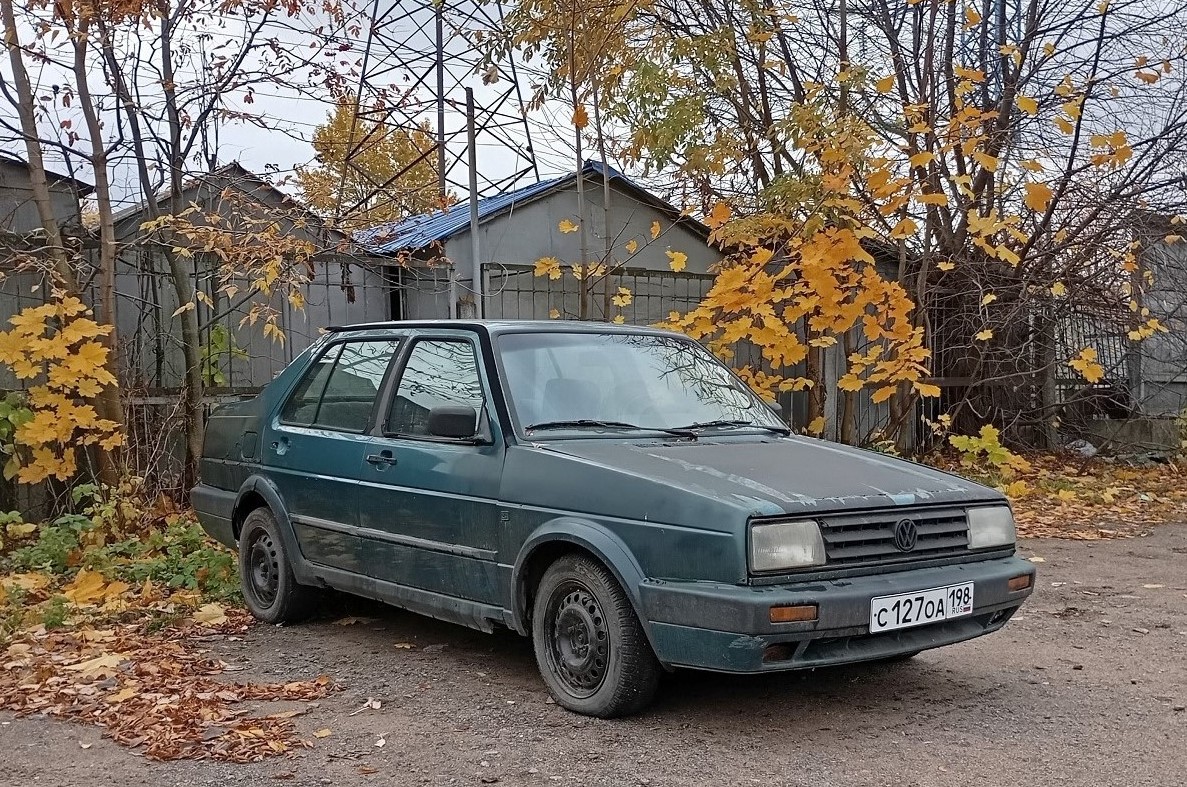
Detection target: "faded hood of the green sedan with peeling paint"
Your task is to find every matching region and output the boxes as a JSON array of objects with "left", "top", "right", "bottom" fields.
[{"left": 538, "top": 436, "right": 1002, "bottom": 515}]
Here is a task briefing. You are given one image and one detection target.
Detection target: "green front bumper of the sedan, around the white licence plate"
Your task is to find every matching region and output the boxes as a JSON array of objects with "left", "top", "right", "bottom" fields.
[{"left": 640, "top": 557, "right": 1035, "bottom": 672}]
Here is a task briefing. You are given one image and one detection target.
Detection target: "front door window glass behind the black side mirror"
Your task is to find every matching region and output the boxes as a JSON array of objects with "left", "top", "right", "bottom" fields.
[{"left": 386, "top": 339, "right": 484, "bottom": 437}]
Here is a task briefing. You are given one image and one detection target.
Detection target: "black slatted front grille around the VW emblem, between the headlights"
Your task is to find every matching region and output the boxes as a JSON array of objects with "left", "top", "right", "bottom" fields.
[{"left": 819, "top": 508, "right": 969, "bottom": 567}]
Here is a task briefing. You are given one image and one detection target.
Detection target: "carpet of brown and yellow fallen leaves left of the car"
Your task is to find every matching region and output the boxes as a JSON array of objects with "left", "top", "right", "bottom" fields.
[{"left": 0, "top": 570, "right": 336, "bottom": 762}]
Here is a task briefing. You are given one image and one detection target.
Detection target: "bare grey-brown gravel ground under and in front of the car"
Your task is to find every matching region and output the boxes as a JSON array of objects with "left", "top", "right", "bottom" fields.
[{"left": 0, "top": 525, "right": 1187, "bottom": 787}]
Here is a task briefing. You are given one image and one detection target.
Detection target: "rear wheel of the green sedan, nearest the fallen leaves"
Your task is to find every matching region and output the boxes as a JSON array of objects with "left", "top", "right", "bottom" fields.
[{"left": 239, "top": 508, "right": 317, "bottom": 623}]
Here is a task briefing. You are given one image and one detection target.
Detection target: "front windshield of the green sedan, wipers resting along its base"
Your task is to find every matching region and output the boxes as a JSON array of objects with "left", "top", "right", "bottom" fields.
[{"left": 499, "top": 332, "right": 786, "bottom": 430}]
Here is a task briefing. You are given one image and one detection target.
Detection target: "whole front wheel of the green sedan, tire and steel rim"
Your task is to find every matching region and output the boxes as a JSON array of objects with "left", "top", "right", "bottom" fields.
[{"left": 532, "top": 554, "right": 660, "bottom": 718}]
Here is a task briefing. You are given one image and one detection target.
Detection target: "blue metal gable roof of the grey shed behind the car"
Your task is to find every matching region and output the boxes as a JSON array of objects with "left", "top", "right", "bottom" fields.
[{"left": 355, "top": 161, "right": 697, "bottom": 254}]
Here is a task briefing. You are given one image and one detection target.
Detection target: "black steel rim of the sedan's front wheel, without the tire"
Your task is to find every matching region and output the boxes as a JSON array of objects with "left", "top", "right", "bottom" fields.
[{"left": 545, "top": 580, "right": 610, "bottom": 699}]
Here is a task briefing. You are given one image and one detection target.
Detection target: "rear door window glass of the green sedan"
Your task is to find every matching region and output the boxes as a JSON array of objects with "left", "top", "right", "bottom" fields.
[{"left": 280, "top": 339, "right": 399, "bottom": 432}]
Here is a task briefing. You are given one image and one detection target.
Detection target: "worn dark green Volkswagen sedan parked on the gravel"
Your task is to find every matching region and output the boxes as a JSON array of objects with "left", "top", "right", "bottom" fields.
[{"left": 192, "top": 320, "right": 1034, "bottom": 717}]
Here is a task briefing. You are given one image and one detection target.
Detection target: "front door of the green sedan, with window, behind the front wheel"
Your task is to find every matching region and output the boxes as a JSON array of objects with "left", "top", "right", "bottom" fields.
[{"left": 348, "top": 331, "right": 503, "bottom": 603}]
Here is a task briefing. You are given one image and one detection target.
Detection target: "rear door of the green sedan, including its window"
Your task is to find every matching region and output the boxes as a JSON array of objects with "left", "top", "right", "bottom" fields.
[{"left": 265, "top": 337, "right": 399, "bottom": 571}]
